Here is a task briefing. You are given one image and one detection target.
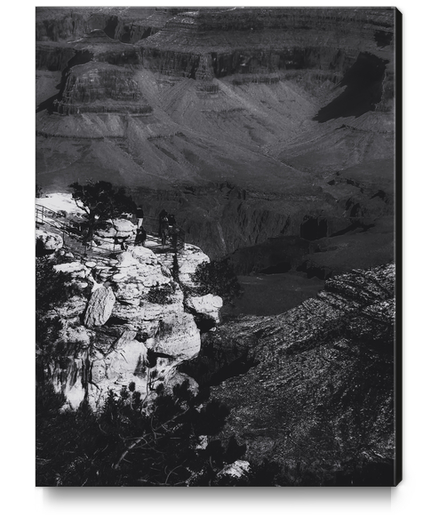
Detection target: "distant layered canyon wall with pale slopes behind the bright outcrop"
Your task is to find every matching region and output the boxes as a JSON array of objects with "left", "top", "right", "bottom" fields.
[{"left": 37, "top": 8, "right": 394, "bottom": 274}]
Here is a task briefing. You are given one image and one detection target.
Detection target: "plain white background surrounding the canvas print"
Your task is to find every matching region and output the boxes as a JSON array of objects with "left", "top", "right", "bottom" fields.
[{"left": 0, "top": 0, "right": 431, "bottom": 515}]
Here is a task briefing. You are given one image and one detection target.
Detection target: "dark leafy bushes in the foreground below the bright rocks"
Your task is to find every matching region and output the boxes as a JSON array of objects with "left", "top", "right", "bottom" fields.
[{"left": 36, "top": 383, "right": 250, "bottom": 486}]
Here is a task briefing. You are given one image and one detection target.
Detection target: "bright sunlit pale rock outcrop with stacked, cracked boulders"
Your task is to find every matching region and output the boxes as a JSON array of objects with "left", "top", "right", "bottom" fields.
[{"left": 37, "top": 198, "right": 222, "bottom": 410}]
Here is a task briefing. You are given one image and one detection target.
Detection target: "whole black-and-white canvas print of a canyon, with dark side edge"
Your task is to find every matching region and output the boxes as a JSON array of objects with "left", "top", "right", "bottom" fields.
[{"left": 35, "top": 6, "right": 401, "bottom": 487}]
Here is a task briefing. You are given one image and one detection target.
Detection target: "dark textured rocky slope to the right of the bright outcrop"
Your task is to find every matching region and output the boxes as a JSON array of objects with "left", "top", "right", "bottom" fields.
[{"left": 185, "top": 265, "right": 395, "bottom": 485}]
